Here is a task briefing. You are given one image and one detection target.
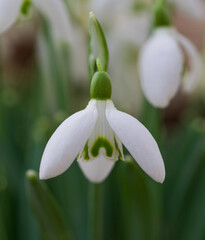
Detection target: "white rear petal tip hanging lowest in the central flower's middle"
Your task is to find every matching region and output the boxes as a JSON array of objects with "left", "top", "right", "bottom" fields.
[{"left": 78, "top": 156, "right": 115, "bottom": 183}]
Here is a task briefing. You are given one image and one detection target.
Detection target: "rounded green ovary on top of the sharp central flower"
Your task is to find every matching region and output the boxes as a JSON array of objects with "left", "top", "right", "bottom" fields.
[{"left": 90, "top": 71, "right": 112, "bottom": 100}]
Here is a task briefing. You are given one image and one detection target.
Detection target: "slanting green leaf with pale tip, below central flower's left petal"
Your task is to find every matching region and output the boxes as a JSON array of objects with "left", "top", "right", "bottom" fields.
[{"left": 26, "top": 170, "right": 71, "bottom": 240}]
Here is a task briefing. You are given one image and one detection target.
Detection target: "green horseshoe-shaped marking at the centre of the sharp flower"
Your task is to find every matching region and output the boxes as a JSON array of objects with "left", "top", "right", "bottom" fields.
[{"left": 91, "top": 137, "right": 113, "bottom": 157}]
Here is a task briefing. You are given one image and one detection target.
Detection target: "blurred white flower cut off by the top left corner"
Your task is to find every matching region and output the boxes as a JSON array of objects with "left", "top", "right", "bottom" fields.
[{"left": 0, "top": 0, "right": 73, "bottom": 42}]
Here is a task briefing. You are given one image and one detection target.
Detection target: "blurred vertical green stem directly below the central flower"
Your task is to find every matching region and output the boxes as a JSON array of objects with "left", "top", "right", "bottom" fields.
[{"left": 87, "top": 183, "right": 103, "bottom": 240}]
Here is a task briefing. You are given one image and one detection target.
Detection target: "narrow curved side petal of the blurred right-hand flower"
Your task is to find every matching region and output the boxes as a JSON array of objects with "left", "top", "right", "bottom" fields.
[{"left": 176, "top": 33, "right": 202, "bottom": 93}]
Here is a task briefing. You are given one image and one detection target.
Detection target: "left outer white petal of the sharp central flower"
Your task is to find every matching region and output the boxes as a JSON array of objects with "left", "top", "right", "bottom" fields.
[{"left": 40, "top": 100, "right": 98, "bottom": 179}]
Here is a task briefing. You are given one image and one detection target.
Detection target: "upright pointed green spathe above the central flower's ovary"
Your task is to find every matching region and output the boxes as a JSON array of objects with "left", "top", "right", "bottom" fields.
[{"left": 88, "top": 12, "right": 109, "bottom": 79}]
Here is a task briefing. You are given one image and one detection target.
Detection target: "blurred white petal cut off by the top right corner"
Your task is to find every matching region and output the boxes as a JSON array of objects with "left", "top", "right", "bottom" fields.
[{"left": 169, "top": 0, "right": 205, "bottom": 20}]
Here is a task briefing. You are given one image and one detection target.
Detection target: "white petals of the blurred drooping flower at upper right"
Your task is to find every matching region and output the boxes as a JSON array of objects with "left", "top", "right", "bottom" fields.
[{"left": 139, "top": 28, "right": 202, "bottom": 108}]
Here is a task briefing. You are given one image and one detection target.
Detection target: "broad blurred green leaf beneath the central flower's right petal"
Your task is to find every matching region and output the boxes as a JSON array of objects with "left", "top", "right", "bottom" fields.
[{"left": 118, "top": 159, "right": 162, "bottom": 240}]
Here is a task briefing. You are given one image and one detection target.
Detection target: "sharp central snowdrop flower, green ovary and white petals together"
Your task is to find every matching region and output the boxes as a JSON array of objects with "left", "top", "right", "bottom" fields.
[{"left": 40, "top": 68, "right": 165, "bottom": 183}]
